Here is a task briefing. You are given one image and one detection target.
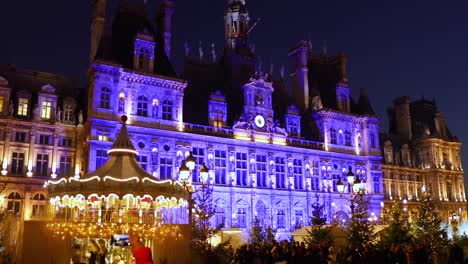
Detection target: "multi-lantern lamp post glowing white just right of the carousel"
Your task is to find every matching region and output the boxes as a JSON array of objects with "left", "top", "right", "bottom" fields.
[{"left": 179, "top": 152, "right": 210, "bottom": 224}]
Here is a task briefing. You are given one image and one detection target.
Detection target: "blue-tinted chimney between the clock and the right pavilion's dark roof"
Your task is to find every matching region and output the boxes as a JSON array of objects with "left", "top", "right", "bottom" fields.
[{"left": 288, "top": 40, "right": 309, "bottom": 111}]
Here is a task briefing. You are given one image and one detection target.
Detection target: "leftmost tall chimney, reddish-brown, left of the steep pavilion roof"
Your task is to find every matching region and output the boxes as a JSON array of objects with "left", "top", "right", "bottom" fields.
[{"left": 89, "top": 0, "right": 106, "bottom": 63}]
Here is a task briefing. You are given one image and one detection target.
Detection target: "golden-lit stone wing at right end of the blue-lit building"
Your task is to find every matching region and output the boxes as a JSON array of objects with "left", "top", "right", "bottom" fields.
[{"left": 382, "top": 97, "right": 467, "bottom": 222}]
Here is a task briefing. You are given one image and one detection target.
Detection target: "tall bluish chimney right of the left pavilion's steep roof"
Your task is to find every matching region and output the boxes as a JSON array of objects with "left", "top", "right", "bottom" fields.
[{"left": 156, "top": 0, "right": 175, "bottom": 58}]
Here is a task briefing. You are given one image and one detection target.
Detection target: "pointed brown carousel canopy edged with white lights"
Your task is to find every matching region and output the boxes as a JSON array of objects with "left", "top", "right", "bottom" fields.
[{"left": 46, "top": 116, "right": 188, "bottom": 200}]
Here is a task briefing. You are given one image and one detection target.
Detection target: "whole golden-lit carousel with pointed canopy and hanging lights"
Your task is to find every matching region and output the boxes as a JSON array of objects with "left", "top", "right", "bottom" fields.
[{"left": 46, "top": 116, "right": 190, "bottom": 263}]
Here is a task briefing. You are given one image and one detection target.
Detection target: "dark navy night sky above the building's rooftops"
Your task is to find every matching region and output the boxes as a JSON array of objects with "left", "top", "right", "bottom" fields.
[{"left": 0, "top": 0, "right": 468, "bottom": 184}]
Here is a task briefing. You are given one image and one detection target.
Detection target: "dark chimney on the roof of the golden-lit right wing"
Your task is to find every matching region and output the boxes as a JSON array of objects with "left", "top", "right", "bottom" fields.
[{"left": 393, "top": 96, "right": 412, "bottom": 141}]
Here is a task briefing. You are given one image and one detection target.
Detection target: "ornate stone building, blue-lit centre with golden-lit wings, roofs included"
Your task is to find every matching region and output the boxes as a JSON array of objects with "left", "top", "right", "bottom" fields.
[{"left": 0, "top": 0, "right": 467, "bottom": 251}]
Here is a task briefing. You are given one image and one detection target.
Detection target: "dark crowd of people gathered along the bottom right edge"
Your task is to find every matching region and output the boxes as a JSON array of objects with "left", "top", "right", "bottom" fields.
[{"left": 213, "top": 241, "right": 468, "bottom": 264}]
